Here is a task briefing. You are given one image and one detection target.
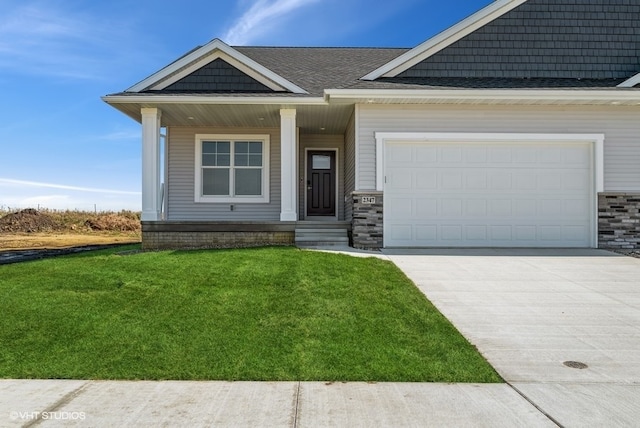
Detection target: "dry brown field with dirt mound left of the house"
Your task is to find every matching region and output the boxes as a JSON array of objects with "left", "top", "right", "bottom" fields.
[{"left": 0, "top": 209, "right": 141, "bottom": 251}]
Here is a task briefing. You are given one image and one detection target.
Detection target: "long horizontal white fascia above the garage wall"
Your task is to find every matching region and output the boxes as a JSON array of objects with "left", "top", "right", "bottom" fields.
[{"left": 325, "top": 89, "right": 640, "bottom": 104}]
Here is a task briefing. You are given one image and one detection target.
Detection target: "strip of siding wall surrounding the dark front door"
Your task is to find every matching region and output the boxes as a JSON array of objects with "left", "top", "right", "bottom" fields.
[{"left": 298, "top": 134, "right": 344, "bottom": 220}]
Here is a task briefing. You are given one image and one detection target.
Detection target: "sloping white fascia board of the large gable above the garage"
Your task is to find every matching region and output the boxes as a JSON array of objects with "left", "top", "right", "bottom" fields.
[{"left": 361, "top": 0, "right": 527, "bottom": 80}]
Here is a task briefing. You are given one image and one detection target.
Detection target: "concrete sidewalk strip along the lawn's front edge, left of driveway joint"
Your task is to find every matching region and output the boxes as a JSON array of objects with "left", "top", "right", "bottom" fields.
[{"left": 0, "top": 380, "right": 555, "bottom": 427}]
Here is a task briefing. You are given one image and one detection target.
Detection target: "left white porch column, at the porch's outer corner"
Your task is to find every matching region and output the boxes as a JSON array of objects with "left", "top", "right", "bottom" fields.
[{"left": 140, "top": 108, "right": 162, "bottom": 221}]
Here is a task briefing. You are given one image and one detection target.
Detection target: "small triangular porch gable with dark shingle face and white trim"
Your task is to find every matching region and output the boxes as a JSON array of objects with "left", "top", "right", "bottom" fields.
[{"left": 125, "top": 39, "right": 307, "bottom": 94}]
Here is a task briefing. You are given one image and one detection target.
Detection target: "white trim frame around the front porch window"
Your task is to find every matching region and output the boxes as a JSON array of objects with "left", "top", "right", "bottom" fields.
[{"left": 194, "top": 134, "right": 270, "bottom": 204}]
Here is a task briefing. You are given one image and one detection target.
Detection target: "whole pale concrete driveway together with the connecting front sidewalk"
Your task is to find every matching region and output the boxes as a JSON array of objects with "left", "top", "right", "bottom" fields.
[{"left": 0, "top": 246, "right": 640, "bottom": 427}]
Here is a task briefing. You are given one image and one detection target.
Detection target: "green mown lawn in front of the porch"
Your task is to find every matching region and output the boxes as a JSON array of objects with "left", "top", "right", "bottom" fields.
[{"left": 0, "top": 247, "right": 501, "bottom": 382}]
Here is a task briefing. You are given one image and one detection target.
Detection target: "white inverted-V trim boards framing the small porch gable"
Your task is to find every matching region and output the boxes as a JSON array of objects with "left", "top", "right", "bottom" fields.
[{"left": 125, "top": 39, "right": 308, "bottom": 94}]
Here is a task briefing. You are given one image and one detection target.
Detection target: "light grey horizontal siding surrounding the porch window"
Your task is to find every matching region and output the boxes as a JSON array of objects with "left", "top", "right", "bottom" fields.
[{"left": 166, "top": 127, "right": 281, "bottom": 221}]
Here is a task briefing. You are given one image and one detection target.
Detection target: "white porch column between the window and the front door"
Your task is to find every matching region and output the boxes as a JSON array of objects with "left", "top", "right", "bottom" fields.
[{"left": 280, "top": 108, "right": 298, "bottom": 221}]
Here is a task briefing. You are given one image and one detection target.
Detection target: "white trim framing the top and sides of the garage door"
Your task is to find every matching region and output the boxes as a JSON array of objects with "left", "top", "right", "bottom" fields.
[{"left": 375, "top": 132, "right": 604, "bottom": 247}]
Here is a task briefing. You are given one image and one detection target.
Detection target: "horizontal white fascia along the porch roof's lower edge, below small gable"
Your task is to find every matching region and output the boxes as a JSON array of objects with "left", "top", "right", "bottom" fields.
[{"left": 102, "top": 94, "right": 328, "bottom": 106}]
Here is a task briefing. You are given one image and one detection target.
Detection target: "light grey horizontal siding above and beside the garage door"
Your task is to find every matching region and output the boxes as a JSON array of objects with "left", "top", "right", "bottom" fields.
[{"left": 356, "top": 105, "right": 640, "bottom": 192}]
